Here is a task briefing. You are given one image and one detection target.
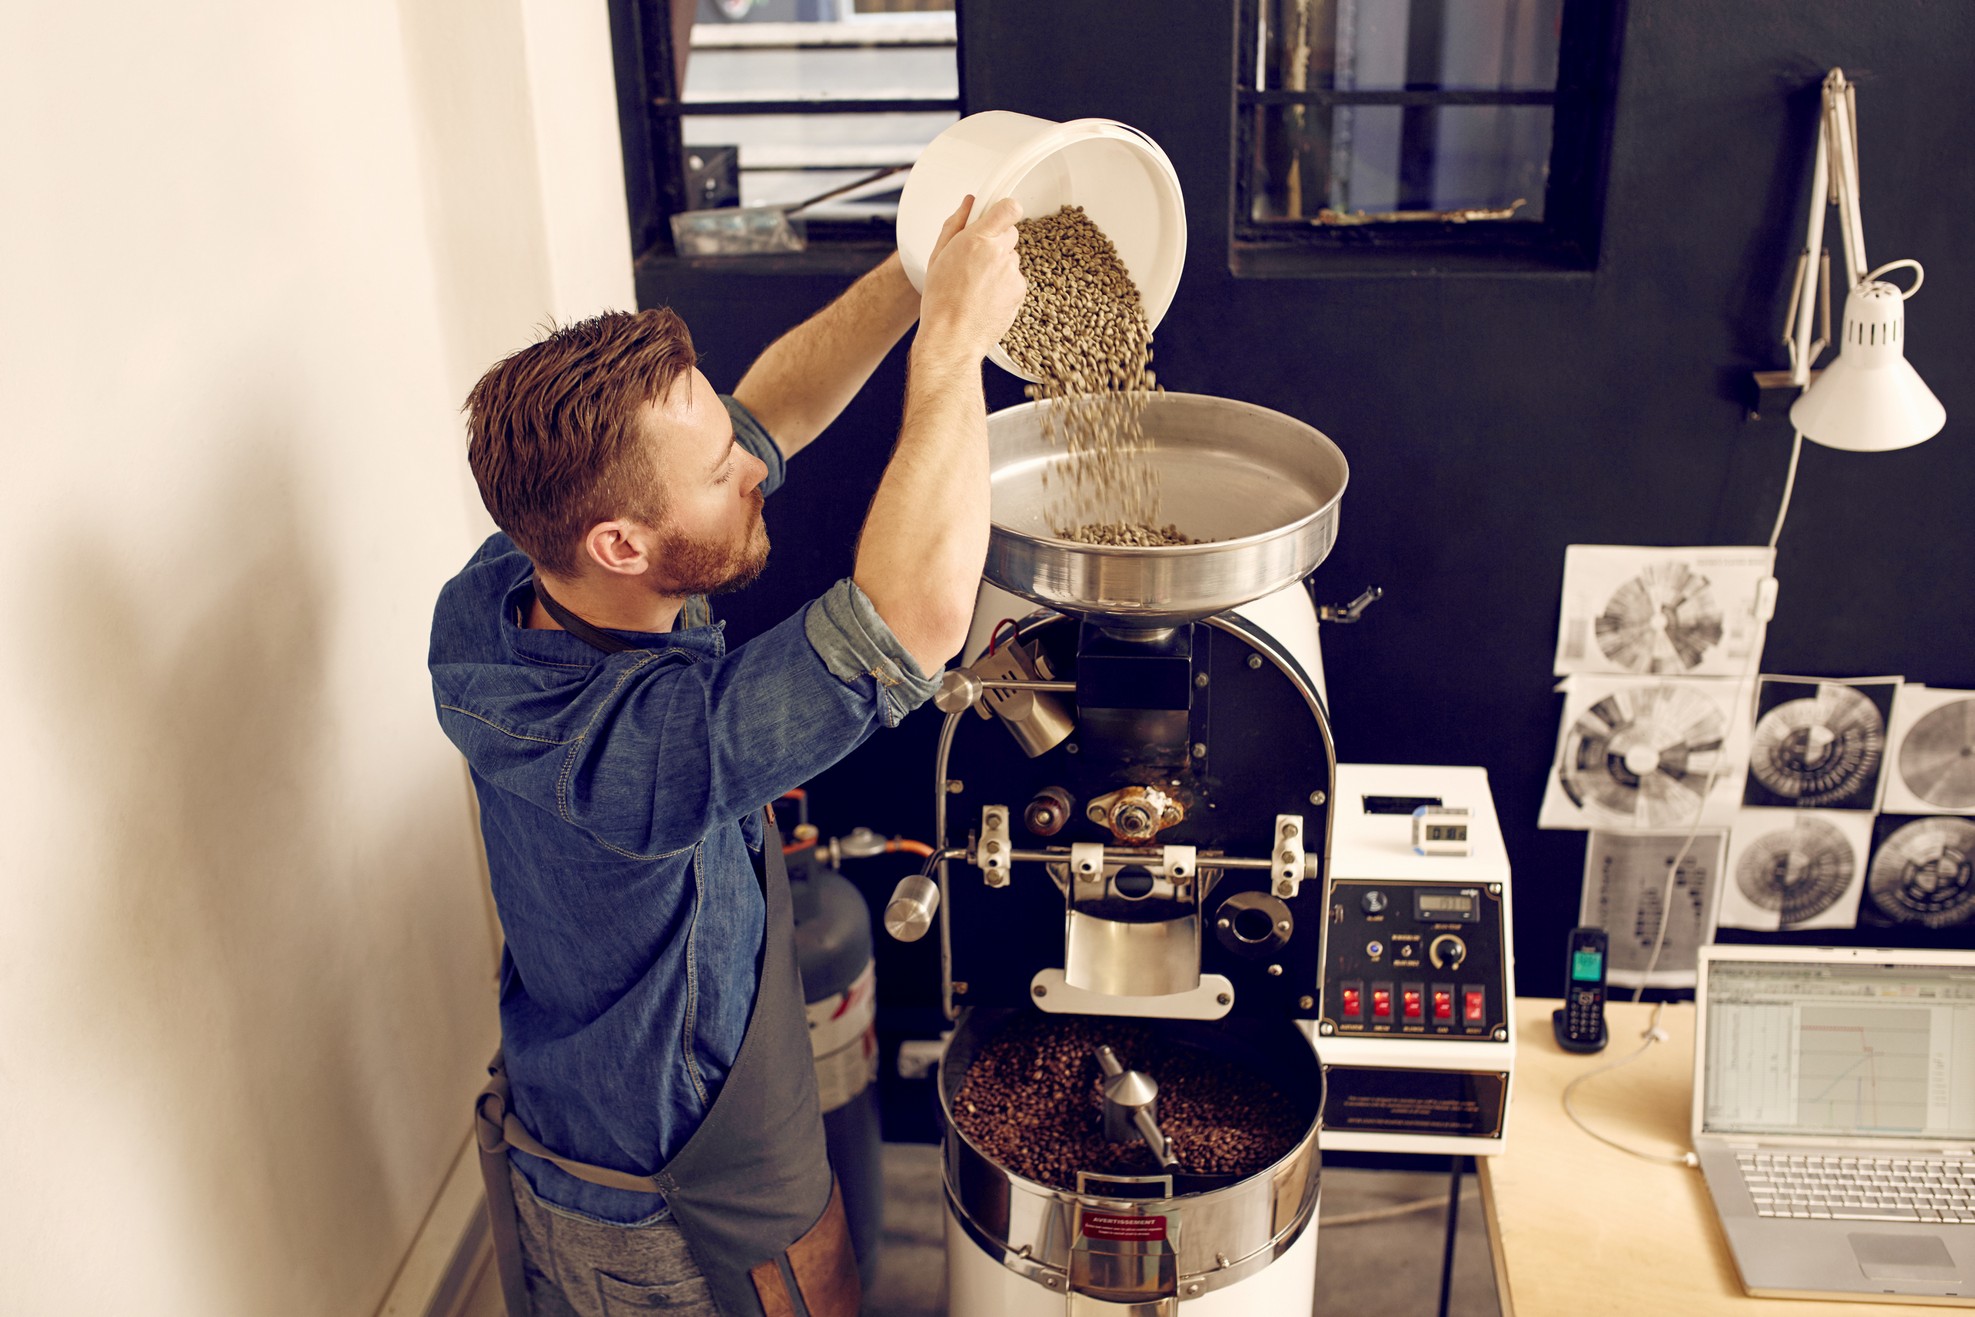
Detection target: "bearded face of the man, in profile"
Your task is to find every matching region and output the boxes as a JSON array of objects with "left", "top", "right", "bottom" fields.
[{"left": 644, "top": 369, "right": 768, "bottom": 596}]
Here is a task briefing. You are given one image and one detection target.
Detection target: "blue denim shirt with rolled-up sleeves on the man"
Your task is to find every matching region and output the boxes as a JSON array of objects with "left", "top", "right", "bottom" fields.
[{"left": 429, "top": 399, "right": 934, "bottom": 1222}]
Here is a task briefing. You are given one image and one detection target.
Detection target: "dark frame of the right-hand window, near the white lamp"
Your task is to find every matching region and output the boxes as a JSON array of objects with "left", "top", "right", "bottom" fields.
[{"left": 1230, "top": 0, "right": 1625, "bottom": 276}]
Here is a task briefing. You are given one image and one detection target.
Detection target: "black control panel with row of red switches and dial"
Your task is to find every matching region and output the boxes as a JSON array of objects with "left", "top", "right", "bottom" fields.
[{"left": 1321, "top": 879, "right": 1507, "bottom": 1041}]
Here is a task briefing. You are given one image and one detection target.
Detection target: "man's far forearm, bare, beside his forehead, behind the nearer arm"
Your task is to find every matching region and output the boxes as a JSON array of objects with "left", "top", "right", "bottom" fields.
[{"left": 735, "top": 253, "right": 918, "bottom": 456}]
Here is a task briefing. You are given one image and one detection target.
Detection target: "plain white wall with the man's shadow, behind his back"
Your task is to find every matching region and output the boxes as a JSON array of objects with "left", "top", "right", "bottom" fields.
[{"left": 0, "top": 0, "right": 632, "bottom": 1317}]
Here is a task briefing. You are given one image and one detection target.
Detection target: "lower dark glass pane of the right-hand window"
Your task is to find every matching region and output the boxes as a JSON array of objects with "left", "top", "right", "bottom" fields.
[{"left": 1248, "top": 105, "right": 1552, "bottom": 223}]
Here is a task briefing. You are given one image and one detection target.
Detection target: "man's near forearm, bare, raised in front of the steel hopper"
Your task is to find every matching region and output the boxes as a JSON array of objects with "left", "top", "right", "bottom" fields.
[{"left": 855, "top": 348, "right": 988, "bottom": 673}]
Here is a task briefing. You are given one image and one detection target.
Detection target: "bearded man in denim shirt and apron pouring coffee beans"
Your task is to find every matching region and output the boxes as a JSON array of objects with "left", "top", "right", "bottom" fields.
[{"left": 431, "top": 197, "right": 1025, "bottom": 1317}]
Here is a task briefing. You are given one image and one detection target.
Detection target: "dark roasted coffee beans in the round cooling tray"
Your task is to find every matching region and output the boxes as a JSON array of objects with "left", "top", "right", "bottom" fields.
[{"left": 954, "top": 1015, "right": 1311, "bottom": 1191}]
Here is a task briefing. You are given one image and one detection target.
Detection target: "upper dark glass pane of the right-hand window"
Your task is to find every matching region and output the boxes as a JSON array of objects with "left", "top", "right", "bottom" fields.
[{"left": 1244, "top": 0, "right": 1564, "bottom": 91}]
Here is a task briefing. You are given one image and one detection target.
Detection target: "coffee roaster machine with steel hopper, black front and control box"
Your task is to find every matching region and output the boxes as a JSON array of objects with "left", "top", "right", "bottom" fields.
[{"left": 885, "top": 393, "right": 1515, "bottom": 1317}]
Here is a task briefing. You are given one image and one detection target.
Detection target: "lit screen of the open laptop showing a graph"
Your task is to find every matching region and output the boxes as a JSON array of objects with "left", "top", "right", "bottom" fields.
[{"left": 1700, "top": 960, "right": 1975, "bottom": 1141}]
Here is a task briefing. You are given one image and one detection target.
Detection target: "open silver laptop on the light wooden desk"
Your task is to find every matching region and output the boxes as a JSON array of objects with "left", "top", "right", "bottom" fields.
[{"left": 1693, "top": 946, "right": 1975, "bottom": 1305}]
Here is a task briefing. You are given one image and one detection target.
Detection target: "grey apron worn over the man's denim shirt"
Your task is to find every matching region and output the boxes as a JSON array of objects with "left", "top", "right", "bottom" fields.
[{"left": 474, "top": 582, "right": 861, "bottom": 1317}]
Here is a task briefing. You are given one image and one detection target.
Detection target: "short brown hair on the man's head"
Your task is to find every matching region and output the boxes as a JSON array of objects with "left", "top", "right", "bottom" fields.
[{"left": 466, "top": 308, "right": 697, "bottom": 575}]
